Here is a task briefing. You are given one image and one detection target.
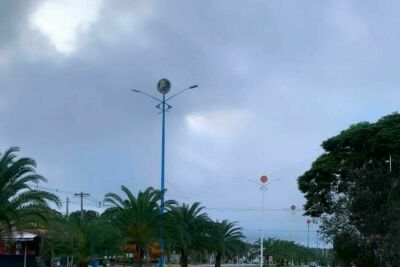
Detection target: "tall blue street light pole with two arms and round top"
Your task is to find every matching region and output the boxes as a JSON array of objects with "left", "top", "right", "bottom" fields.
[{"left": 132, "top": 79, "right": 198, "bottom": 267}]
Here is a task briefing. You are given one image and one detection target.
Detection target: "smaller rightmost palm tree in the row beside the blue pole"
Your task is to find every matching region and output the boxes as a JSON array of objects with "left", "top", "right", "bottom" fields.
[{"left": 210, "top": 220, "right": 246, "bottom": 267}]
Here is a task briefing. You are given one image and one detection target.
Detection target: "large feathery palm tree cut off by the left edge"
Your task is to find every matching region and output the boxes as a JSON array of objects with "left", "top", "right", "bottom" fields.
[{"left": 0, "top": 147, "right": 60, "bottom": 240}]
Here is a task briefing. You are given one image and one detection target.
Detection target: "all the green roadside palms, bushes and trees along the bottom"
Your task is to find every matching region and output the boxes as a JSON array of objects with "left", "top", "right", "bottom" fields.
[{"left": 10, "top": 113, "right": 400, "bottom": 267}]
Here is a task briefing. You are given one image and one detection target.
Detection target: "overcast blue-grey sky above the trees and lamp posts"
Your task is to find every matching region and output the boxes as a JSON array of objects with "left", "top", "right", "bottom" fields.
[{"left": 0, "top": 0, "right": 400, "bottom": 246}]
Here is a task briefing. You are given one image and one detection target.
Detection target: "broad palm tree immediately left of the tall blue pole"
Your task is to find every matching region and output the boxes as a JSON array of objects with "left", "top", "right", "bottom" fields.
[{"left": 105, "top": 186, "right": 174, "bottom": 266}]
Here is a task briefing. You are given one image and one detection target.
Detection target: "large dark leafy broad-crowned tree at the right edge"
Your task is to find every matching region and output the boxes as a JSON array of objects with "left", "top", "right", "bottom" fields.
[{"left": 298, "top": 113, "right": 400, "bottom": 266}]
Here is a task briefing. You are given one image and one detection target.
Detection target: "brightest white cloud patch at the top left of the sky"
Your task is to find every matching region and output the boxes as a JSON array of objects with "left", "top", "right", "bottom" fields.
[{"left": 29, "top": 0, "right": 103, "bottom": 55}]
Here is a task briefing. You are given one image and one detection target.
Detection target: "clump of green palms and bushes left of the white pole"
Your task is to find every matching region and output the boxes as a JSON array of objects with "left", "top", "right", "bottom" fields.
[{"left": 0, "top": 147, "right": 245, "bottom": 267}]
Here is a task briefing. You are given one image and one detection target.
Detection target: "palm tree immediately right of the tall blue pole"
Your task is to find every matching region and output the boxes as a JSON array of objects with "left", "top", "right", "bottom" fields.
[{"left": 166, "top": 202, "right": 210, "bottom": 267}]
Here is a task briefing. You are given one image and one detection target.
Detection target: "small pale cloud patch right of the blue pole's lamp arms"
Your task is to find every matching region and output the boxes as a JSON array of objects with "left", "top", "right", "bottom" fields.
[{"left": 185, "top": 110, "right": 248, "bottom": 138}]
